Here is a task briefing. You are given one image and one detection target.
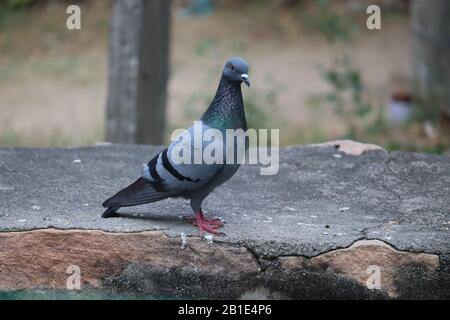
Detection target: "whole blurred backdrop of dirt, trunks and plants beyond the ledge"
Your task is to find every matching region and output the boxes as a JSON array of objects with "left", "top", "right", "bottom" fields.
[{"left": 0, "top": 0, "right": 450, "bottom": 154}]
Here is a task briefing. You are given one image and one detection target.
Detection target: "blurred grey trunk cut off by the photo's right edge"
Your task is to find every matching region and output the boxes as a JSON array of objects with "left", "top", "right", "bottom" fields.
[{"left": 412, "top": 0, "right": 450, "bottom": 119}]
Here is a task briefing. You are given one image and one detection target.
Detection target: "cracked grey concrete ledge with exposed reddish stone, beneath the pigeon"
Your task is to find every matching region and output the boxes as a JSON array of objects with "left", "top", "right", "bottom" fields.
[{"left": 0, "top": 141, "right": 450, "bottom": 299}]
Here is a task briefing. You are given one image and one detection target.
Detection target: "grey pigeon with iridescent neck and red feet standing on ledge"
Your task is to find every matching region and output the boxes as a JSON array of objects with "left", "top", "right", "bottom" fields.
[{"left": 102, "top": 57, "right": 250, "bottom": 235}]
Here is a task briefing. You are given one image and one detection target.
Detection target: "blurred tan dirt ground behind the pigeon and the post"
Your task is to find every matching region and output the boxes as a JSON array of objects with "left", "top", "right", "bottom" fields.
[{"left": 0, "top": 0, "right": 411, "bottom": 146}]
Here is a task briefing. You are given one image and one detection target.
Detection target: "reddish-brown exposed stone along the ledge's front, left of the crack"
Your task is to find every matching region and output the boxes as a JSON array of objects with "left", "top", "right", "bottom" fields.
[{"left": 0, "top": 229, "right": 259, "bottom": 295}]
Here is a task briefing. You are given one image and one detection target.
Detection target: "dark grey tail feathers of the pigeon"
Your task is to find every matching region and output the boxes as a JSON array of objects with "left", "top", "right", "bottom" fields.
[{"left": 103, "top": 178, "right": 173, "bottom": 208}]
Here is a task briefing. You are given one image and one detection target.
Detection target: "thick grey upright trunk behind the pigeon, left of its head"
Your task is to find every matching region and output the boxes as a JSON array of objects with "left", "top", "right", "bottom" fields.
[{"left": 106, "top": 0, "right": 170, "bottom": 144}]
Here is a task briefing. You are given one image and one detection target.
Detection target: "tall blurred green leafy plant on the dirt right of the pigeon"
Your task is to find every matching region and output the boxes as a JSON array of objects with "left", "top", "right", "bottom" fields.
[{"left": 308, "top": 0, "right": 387, "bottom": 139}]
